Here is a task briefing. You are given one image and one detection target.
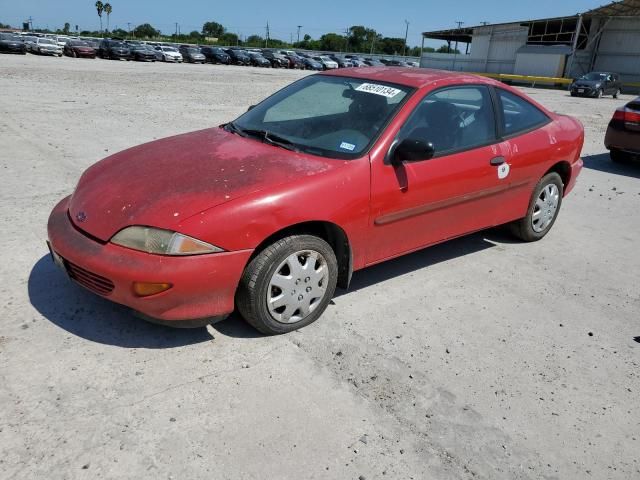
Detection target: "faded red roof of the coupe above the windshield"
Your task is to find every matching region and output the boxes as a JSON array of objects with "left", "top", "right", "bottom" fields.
[{"left": 323, "top": 67, "right": 501, "bottom": 88}]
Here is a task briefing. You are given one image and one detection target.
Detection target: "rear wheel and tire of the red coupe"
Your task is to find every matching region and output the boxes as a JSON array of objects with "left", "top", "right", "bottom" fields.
[{"left": 511, "top": 172, "right": 564, "bottom": 242}]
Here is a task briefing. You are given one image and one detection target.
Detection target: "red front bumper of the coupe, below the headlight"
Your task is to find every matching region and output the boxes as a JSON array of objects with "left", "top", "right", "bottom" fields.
[{"left": 47, "top": 197, "right": 252, "bottom": 321}]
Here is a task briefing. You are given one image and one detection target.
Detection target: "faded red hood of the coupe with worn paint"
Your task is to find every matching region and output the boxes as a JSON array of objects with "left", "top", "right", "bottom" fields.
[{"left": 69, "top": 128, "right": 345, "bottom": 241}]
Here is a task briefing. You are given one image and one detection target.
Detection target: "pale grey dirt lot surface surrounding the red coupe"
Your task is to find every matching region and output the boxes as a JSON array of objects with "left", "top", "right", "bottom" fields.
[{"left": 0, "top": 55, "right": 640, "bottom": 479}]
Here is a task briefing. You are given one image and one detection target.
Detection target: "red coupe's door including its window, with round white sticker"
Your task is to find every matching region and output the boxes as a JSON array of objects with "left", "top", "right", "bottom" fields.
[{"left": 367, "top": 85, "right": 510, "bottom": 264}]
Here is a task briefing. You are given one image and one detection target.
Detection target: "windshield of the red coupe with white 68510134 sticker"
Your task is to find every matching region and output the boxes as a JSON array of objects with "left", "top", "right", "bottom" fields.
[{"left": 227, "top": 75, "right": 412, "bottom": 159}]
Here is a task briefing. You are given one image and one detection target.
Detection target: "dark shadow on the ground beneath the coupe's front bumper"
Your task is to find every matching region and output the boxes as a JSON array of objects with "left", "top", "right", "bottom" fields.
[{"left": 28, "top": 255, "right": 213, "bottom": 348}]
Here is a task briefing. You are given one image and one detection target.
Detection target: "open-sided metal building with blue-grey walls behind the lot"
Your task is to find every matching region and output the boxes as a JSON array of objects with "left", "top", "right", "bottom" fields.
[{"left": 420, "top": 0, "right": 640, "bottom": 86}]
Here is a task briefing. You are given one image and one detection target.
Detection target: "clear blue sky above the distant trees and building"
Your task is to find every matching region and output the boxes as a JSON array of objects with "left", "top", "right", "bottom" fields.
[{"left": 0, "top": 0, "right": 608, "bottom": 46}]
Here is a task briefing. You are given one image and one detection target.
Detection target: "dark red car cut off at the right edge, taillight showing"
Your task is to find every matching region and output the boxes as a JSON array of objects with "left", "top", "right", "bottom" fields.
[{"left": 604, "top": 97, "right": 640, "bottom": 162}]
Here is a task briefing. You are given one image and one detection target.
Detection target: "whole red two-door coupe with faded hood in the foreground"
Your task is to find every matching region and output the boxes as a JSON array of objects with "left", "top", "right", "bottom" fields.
[{"left": 48, "top": 67, "right": 584, "bottom": 334}]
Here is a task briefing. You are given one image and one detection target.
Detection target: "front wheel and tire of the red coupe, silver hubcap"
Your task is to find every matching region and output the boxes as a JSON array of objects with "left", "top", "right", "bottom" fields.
[{"left": 236, "top": 235, "right": 338, "bottom": 335}]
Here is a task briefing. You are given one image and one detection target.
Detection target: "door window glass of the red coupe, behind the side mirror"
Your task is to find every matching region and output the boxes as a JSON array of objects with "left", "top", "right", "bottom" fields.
[{"left": 399, "top": 85, "right": 496, "bottom": 156}]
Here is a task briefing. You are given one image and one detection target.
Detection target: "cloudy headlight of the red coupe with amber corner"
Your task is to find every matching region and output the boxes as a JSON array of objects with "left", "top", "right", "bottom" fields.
[{"left": 111, "top": 226, "right": 224, "bottom": 255}]
